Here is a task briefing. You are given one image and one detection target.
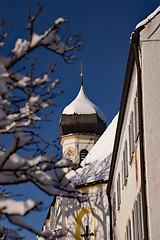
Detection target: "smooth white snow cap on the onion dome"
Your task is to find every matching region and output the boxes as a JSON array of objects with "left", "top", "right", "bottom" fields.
[{"left": 62, "top": 86, "right": 106, "bottom": 122}]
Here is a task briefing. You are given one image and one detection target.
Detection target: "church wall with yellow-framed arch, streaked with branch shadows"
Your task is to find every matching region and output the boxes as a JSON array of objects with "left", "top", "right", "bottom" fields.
[{"left": 51, "top": 185, "right": 109, "bottom": 240}]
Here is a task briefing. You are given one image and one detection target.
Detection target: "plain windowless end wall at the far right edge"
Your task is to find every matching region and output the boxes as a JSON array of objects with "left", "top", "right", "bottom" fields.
[{"left": 140, "top": 14, "right": 160, "bottom": 240}]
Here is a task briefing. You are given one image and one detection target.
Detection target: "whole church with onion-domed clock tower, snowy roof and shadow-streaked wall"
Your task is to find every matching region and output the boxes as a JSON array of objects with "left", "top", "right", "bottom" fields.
[{"left": 38, "top": 64, "right": 116, "bottom": 240}]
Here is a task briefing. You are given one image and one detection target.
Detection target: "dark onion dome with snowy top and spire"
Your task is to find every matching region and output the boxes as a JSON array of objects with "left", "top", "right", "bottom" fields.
[{"left": 59, "top": 73, "right": 106, "bottom": 136}]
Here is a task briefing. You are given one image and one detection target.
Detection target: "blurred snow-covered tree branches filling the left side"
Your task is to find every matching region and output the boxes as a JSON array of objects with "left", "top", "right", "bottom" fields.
[{"left": 0, "top": 3, "right": 81, "bottom": 239}]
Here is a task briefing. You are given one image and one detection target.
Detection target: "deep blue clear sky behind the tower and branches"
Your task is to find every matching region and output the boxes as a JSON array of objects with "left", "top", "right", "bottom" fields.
[{"left": 0, "top": 0, "right": 159, "bottom": 240}]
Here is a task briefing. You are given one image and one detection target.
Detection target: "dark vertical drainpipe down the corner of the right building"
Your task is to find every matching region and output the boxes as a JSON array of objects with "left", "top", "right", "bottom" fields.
[{"left": 132, "top": 29, "right": 149, "bottom": 240}]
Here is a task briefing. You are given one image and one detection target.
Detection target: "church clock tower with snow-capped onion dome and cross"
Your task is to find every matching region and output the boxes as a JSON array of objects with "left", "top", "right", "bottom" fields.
[{"left": 59, "top": 64, "right": 106, "bottom": 163}]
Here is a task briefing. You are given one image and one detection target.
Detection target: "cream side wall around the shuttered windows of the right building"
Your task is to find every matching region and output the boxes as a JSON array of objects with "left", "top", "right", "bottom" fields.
[{"left": 111, "top": 62, "right": 141, "bottom": 240}]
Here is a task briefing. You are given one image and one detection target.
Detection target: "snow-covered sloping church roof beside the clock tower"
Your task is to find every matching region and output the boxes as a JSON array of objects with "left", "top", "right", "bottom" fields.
[{"left": 67, "top": 114, "right": 118, "bottom": 185}]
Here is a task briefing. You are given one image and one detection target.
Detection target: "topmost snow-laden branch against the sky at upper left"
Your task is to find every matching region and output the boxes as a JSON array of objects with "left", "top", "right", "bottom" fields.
[{"left": 5, "top": 3, "right": 81, "bottom": 69}]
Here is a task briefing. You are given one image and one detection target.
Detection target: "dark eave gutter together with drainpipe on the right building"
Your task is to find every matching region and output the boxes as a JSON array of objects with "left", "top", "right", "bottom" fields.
[{"left": 107, "top": 26, "right": 148, "bottom": 240}]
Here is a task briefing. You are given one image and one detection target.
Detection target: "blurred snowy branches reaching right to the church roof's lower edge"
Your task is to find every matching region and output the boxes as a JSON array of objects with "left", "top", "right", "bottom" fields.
[{"left": 0, "top": 151, "right": 78, "bottom": 197}]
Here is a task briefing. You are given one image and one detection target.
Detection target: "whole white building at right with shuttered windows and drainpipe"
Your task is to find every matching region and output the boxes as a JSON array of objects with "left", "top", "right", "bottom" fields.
[{"left": 107, "top": 8, "right": 160, "bottom": 240}]
